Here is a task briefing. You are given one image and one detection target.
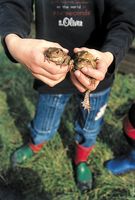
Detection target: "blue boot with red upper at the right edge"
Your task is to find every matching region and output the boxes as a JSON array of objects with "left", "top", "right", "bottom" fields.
[{"left": 105, "top": 115, "right": 135, "bottom": 175}]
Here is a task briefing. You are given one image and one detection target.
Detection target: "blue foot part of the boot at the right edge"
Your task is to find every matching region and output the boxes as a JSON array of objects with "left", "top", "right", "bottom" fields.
[{"left": 105, "top": 149, "right": 135, "bottom": 175}]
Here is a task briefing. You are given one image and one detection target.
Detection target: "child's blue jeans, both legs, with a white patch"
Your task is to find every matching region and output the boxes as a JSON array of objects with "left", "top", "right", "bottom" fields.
[{"left": 30, "top": 88, "right": 110, "bottom": 147}]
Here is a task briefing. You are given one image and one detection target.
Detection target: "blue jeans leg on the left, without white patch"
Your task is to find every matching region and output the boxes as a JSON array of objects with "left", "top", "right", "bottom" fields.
[{"left": 30, "top": 94, "right": 71, "bottom": 144}]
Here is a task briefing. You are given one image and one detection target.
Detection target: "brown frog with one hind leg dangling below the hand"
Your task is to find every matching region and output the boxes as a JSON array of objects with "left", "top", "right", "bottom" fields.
[{"left": 73, "top": 50, "right": 98, "bottom": 112}]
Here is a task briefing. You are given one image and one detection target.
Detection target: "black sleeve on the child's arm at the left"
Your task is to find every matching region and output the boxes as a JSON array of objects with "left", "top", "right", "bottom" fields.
[{"left": 0, "top": 0, "right": 33, "bottom": 61}]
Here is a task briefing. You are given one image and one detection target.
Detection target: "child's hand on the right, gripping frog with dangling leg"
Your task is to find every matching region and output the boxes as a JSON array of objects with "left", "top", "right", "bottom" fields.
[{"left": 71, "top": 48, "right": 114, "bottom": 92}]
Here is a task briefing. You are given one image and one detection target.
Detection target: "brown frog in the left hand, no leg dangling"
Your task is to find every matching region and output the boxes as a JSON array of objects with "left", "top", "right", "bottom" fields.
[{"left": 44, "top": 47, "right": 73, "bottom": 69}]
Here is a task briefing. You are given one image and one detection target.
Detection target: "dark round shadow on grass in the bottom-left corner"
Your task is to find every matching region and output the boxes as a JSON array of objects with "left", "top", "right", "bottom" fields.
[{"left": 0, "top": 168, "right": 52, "bottom": 200}]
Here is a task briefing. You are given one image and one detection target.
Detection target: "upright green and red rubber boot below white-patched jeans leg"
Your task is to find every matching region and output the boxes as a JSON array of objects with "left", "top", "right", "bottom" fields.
[{"left": 75, "top": 144, "right": 93, "bottom": 192}]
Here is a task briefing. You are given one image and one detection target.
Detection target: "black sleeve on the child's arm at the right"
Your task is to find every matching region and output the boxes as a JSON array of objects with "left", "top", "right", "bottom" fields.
[{"left": 102, "top": 0, "right": 135, "bottom": 67}]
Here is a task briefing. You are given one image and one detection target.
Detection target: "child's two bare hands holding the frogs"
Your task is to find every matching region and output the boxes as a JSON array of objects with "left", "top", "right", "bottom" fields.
[{"left": 5, "top": 34, "right": 113, "bottom": 92}]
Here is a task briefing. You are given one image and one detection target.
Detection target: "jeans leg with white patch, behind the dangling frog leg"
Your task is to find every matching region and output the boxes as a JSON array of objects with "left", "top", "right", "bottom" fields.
[{"left": 75, "top": 88, "right": 110, "bottom": 147}]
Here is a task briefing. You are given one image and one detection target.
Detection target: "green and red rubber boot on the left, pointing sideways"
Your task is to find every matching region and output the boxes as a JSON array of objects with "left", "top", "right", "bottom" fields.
[{"left": 11, "top": 142, "right": 44, "bottom": 167}]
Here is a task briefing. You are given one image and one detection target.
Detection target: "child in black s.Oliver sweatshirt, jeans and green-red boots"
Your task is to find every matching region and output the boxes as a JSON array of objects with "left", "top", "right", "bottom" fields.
[{"left": 0, "top": 0, "right": 135, "bottom": 190}]
